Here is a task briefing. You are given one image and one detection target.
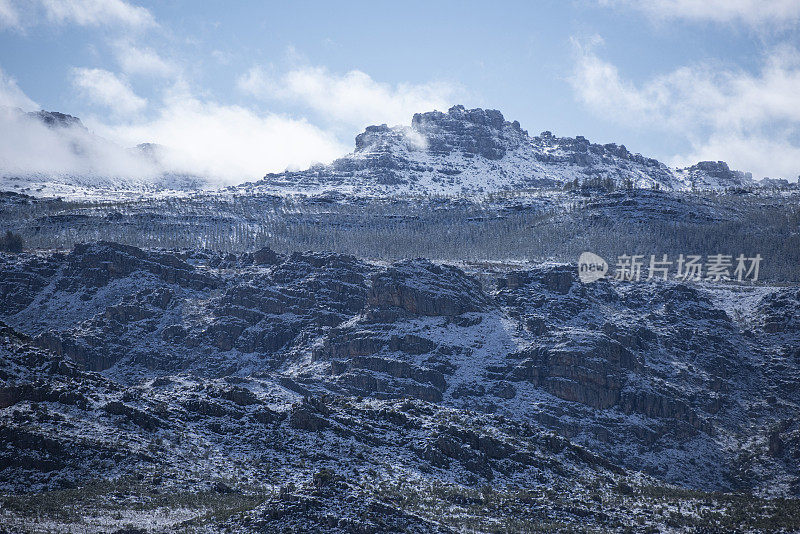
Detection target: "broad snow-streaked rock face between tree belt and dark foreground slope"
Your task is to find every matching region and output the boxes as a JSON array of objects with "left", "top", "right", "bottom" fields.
[{"left": 0, "top": 245, "right": 800, "bottom": 496}]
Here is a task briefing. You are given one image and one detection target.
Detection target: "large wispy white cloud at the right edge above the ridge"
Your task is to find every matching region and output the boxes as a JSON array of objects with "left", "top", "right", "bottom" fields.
[{"left": 571, "top": 38, "right": 800, "bottom": 178}]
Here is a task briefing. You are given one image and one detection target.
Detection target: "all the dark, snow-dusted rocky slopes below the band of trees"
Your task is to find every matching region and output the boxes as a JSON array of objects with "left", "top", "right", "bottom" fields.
[{"left": 0, "top": 243, "right": 800, "bottom": 532}]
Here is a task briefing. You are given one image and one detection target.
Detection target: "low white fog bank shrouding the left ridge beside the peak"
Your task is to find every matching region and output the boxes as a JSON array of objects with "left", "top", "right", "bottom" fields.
[{"left": 0, "top": 103, "right": 344, "bottom": 189}]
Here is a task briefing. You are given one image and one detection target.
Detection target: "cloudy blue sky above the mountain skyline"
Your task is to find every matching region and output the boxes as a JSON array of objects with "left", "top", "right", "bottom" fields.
[{"left": 0, "top": 0, "right": 800, "bottom": 183}]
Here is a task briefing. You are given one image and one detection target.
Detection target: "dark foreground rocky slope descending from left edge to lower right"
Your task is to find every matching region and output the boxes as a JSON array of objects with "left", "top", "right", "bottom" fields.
[{"left": 0, "top": 325, "right": 676, "bottom": 532}]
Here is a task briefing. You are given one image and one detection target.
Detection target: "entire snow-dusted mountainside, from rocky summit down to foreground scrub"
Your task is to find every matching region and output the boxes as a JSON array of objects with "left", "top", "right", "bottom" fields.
[{"left": 0, "top": 107, "right": 800, "bottom": 534}]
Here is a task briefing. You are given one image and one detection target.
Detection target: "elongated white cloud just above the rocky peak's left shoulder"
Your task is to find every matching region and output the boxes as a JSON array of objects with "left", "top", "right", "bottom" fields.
[{"left": 237, "top": 67, "right": 462, "bottom": 127}]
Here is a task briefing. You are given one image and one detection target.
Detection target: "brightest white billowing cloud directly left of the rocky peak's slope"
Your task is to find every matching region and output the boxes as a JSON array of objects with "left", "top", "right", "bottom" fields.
[{"left": 94, "top": 91, "right": 346, "bottom": 183}]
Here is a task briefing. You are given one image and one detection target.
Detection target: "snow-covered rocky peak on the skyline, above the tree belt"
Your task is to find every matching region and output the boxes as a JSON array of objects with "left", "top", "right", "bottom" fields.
[{"left": 241, "top": 105, "right": 754, "bottom": 195}]
